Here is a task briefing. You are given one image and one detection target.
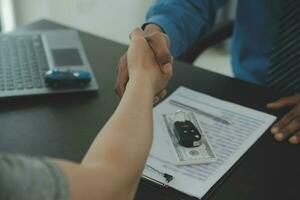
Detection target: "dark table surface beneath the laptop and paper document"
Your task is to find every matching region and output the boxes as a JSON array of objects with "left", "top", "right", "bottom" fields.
[{"left": 0, "top": 20, "right": 300, "bottom": 200}]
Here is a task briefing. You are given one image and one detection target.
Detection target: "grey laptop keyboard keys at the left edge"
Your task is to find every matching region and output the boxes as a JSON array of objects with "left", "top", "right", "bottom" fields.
[{"left": 0, "top": 35, "right": 49, "bottom": 91}]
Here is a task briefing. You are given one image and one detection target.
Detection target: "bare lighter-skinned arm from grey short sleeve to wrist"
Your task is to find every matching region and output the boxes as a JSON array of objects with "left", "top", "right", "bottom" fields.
[{"left": 56, "top": 79, "right": 154, "bottom": 200}]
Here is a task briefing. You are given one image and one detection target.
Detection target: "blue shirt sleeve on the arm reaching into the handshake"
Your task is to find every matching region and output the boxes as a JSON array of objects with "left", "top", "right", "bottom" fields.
[{"left": 146, "top": 0, "right": 227, "bottom": 57}]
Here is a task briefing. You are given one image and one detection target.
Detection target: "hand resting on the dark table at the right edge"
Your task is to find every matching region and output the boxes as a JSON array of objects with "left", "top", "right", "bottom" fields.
[{"left": 267, "top": 94, "right": 300, "bottom": 144}]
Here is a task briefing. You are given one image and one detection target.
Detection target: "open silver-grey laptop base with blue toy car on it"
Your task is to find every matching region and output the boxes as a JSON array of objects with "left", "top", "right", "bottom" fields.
[{"left": 0, "top": 30, "right": 98, "bottom": 98}]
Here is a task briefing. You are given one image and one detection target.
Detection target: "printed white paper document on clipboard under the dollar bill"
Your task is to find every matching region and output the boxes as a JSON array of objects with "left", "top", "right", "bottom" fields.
[{"left": 143, "top": 87, "right": 276, "bottom": 199}]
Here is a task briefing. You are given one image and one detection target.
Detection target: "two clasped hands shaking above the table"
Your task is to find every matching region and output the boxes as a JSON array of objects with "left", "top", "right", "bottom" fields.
[{"left": 115, "top": 24, "right": 173, "bottom": 104}]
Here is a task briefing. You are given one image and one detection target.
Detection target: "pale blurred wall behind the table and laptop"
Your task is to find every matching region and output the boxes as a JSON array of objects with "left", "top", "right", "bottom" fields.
[{"left": 13, "top": 0, "right": 155, "bottom": 43}]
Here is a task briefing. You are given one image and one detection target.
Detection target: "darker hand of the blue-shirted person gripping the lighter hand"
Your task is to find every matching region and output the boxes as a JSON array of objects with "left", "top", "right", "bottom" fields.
[{"left": 115, "top": 24, "right": 173, "bottom": 103}]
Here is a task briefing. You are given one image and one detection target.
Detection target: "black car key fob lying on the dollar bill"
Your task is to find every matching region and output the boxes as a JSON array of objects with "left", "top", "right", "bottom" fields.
[{"left": 174, "top": 120, "right": 201, "bottom": 147}]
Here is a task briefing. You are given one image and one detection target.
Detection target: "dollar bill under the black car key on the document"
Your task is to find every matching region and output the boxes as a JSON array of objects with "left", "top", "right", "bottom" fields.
[{"left": 163, "top": 112, "right": 217, "bottom": 165}]
